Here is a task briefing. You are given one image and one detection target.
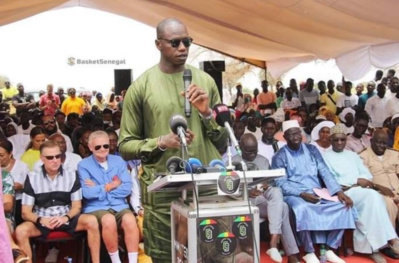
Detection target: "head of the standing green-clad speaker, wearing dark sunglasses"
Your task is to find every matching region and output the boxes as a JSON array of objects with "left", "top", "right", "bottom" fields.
[{"left": 155, "top": 23, "right": 191, "bottom": 66}]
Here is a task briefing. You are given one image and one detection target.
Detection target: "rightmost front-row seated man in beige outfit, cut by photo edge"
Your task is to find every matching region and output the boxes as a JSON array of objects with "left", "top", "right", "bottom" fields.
[{"left": 359, "top": 129, "right": 399, "bottom": 227}]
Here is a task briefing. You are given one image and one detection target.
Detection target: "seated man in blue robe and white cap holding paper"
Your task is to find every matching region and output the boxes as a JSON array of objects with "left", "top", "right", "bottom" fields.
[{"left": 272, "top": 120, "right": 356, "bottom": 263}]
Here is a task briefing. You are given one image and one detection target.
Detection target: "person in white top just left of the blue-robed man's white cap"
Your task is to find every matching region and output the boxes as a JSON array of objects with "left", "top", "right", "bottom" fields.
[{"left": 258, "top": 117, "right": 286, "bottom": 164}]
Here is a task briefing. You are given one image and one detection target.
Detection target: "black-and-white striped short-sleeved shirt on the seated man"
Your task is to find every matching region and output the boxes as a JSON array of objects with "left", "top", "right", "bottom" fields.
[{"left": 22, "top": 166, "right": 82, "bottom": 217}]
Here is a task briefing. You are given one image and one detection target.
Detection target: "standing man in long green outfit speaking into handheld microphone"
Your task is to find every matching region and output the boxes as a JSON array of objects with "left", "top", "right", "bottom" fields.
[{"left": 119, "top": 18, "right": 228, "bottom": 263}]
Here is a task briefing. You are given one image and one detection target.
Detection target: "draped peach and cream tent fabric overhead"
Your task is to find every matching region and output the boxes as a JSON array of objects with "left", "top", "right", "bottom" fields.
[{"left": 0, "top": 0, "right": 399, "bottom": 80}]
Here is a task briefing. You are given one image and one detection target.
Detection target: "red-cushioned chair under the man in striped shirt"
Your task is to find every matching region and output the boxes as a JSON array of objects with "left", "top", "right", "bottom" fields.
[{"left": 31, "top": 231, "right": 90, "bottom": 263}]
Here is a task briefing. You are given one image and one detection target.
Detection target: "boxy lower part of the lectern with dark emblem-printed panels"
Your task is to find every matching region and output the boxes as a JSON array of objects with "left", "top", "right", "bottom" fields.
[{"left": 171, "top": 201, "right": 260, "bottom": 263}]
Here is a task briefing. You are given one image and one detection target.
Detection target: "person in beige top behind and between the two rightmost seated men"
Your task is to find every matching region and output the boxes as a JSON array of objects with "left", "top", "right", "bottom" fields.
[{"left": 345, "top": 113, "right": 370, "bottom": 153}]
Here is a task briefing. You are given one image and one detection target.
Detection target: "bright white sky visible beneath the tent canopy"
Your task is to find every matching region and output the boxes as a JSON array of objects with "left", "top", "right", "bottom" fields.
[{"left": 0, "top": 7, "right": 375, "bottom": 96}]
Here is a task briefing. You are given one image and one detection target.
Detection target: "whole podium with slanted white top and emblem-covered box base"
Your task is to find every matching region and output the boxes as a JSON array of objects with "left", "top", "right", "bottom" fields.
[{"left": 147, "top": 169, "right": 285, "bottom": 263}]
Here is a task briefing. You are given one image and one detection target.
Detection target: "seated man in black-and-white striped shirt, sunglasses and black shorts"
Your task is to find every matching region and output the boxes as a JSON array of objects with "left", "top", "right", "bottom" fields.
[{"left": 15, "top": 141, "right": 100, "bottom": 263}]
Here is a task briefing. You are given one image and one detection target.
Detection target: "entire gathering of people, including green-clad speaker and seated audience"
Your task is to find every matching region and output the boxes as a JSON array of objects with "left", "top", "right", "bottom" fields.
[{"left": 0, "top": 16, "right": 399, "bottom": 263}]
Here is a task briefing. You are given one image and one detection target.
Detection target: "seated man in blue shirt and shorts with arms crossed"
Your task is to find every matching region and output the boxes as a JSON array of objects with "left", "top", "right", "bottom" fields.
[{"left": 78, "top": 131, "right": 139, "bottom": 263}]
